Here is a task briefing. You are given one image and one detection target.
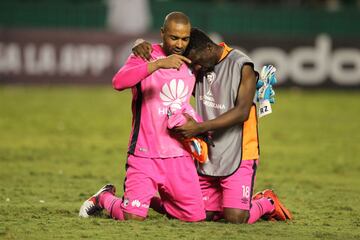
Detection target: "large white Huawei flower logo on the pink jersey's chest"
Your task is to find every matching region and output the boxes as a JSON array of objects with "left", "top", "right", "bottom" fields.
[{"left": 160, "top": 79, "right": 189, "bottom": 111}]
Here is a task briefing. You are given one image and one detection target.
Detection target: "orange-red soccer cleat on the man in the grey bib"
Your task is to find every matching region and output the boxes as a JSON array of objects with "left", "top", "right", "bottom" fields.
[{"left": 260, "top": 189, "right": 293, "bottom": 221}]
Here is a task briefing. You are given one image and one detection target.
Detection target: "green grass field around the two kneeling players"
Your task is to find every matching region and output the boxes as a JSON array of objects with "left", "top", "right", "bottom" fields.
[{"left": 0, "top": 86, "right": 360, "bottom": 240}]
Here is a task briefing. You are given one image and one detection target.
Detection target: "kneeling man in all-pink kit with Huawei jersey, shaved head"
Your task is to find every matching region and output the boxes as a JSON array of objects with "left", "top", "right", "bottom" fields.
[{"left": 79, "top": 12, "right": 205, "bottom": 222}]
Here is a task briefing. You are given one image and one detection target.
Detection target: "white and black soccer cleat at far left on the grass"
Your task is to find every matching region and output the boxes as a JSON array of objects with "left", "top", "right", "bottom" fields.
[{"left": 79, "top": 184, "right": 116, "bottom": 218}]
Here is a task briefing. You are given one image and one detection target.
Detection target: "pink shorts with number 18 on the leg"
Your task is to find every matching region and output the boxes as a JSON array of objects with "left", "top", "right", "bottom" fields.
[{"left": 199, "top": 160, "right": 258, "bottom": 211}]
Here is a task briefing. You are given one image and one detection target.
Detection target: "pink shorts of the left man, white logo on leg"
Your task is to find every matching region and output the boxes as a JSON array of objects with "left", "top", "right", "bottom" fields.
[{"left": 121, "top": 155, "right": 205, "bottom": 222}]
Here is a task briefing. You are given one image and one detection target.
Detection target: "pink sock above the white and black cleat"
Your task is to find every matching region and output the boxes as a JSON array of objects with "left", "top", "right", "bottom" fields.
[{"left": 99, "top": 192, "right": 124, "bottom": 220}]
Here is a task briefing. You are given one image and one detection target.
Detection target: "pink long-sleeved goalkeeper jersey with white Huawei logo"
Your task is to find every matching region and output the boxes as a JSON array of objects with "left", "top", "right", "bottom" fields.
[{"left": 113, "top": 44, "right": 195, "bottom": 158}]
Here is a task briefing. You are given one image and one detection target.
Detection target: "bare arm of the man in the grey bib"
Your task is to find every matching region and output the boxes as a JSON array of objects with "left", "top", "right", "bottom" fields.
[{"left": 174, "top": 65, "right": 256, "bottom": 138}]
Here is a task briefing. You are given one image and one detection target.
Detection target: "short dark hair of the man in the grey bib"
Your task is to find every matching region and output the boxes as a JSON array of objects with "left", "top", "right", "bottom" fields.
[{"left": 184, "top": 28, "right": 216, "bottom": 56}]
